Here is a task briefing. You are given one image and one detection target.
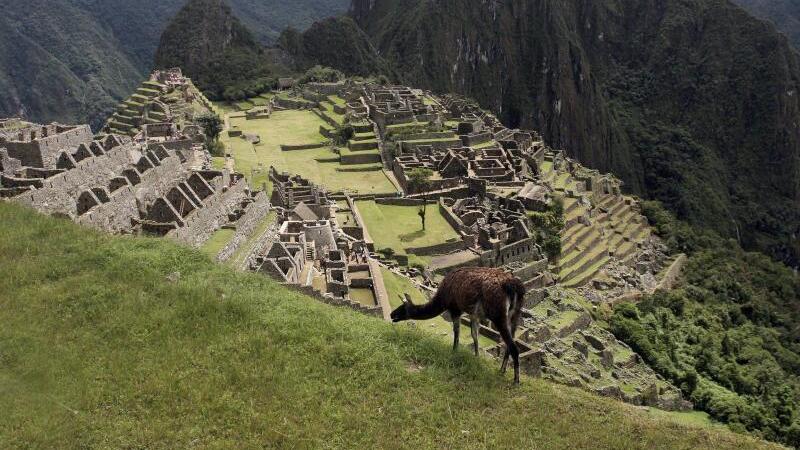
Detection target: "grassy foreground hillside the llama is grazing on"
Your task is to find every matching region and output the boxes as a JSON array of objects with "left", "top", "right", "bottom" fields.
[{"left": 0, "top": 203, "right": 780, "bottom": 448}]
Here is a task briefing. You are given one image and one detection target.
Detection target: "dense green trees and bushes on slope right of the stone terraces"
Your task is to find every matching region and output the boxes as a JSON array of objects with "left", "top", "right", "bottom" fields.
[{"left": 610, "top": 203, "right": 800, "bottom": 446}]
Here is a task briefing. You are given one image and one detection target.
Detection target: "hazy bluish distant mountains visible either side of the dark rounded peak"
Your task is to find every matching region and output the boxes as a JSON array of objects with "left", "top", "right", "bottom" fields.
[{"left": 0, "top": 0, "right": 348, "bottom": 125}]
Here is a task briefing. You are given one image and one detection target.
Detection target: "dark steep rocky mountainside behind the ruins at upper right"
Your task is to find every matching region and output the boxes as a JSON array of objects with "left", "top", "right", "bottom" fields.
[{"left": 351, "top": 0, "right": 800, "bottom": 263}]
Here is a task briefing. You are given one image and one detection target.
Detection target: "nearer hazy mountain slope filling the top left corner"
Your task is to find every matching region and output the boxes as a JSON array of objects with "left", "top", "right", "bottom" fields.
[{"left": 0, "top": 0, "right": 141, "bottom": 130}]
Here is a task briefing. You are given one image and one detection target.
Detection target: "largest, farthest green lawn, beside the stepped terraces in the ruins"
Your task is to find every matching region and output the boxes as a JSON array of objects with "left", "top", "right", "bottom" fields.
[{"left": 222, "top": 111, "right": 397, "bottom": 193}]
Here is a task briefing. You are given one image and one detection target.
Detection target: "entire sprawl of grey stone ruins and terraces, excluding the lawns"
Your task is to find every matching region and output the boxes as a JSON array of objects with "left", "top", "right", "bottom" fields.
[{"left": 0, "top": 70, "right": 687, "bottom": 409}]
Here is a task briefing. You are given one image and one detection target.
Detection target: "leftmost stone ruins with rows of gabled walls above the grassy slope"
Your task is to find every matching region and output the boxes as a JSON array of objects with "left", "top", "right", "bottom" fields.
[{"left": 0, "top": 112, "right": 267, "bottom": 250}]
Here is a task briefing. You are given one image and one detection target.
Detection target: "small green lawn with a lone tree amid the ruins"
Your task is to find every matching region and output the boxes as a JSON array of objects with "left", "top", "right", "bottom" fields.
[{"left": 356, "top": 201, "right": 460, "bottom": 253}]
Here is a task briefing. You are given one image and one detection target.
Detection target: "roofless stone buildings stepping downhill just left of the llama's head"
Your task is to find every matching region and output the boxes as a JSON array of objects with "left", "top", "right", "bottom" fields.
[{"left": 249, "top": 167, "right": 389, "bottom": 317}]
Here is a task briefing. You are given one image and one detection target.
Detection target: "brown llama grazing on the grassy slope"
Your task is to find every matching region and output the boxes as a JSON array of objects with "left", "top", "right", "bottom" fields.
[{"left": 391, "top": 267, "right": 525, "bottom": 384}]
